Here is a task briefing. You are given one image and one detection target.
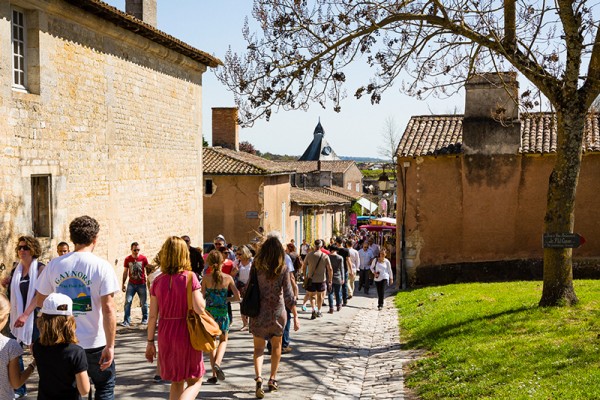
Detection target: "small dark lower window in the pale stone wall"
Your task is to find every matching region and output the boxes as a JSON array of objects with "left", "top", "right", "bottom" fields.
[{"left": 31, "top": 175, "right": 52, "bottom": 237}]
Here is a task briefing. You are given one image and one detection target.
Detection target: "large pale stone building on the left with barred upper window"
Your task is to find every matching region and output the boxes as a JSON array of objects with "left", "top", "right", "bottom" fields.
[{"left": 0, "top": 0, "right": 220, "bottom": 266}]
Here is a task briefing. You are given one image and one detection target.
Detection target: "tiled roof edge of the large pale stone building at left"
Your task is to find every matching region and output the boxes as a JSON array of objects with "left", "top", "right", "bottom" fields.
[{"left": 65, "top": 0, "right": 223, "bottom": 68}]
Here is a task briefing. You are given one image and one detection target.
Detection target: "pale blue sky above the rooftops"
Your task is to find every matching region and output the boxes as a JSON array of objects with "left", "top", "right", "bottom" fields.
[{"left": 104, "top": 0, "right": 464, "bottom": 157}]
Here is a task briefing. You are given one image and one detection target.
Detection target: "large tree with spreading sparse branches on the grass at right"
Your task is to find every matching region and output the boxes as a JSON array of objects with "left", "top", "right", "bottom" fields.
[{"left": 218, "top": 0, "right": 600, "bottom": 305}]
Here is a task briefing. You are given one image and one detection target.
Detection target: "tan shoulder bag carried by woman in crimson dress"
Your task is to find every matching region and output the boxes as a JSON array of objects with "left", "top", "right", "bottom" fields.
[{"left": 186, "top": 272, "right": 221, "bottom": 352}]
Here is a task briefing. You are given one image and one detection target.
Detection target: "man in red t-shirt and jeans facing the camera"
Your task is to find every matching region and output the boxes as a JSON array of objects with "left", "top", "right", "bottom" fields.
[{"left": 119, "top": 242, "right": 148, "bottom": 327}]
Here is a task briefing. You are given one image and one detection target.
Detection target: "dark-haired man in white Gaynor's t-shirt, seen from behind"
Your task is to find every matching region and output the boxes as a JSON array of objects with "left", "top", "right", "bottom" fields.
[{"left": 36, "top": 215, "right": 120, "bottom": 399}]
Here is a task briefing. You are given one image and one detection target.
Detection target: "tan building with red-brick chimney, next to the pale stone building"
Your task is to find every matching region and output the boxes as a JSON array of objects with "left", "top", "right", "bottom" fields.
[{"left": 203, "top": 108, "right": 293, "bottom": 245}]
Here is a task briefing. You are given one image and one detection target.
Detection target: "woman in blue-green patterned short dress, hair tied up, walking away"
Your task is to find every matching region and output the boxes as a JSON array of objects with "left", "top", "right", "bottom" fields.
[{"left": 202, "top": 250, "right": 240, "bottom": 383}]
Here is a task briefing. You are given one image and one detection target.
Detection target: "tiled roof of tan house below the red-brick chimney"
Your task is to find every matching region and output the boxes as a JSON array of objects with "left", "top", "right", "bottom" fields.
[{"left": 202, "top": 147, "right": 294, "bottom": 175}]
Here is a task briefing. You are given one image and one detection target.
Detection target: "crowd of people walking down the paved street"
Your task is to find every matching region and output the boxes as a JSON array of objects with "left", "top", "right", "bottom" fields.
[{"left": 0, "top": 216, "right": 394, "bottom": 399}]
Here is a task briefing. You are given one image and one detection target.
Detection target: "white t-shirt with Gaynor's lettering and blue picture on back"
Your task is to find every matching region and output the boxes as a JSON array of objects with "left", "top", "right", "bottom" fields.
[{"left": 36, "top": 251, "right": 120, "bottom": 349}]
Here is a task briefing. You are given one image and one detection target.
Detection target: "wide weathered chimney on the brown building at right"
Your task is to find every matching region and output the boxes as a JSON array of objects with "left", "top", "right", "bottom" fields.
[{"left": 462, "top": 72, "right": 521, "bottom": 155}]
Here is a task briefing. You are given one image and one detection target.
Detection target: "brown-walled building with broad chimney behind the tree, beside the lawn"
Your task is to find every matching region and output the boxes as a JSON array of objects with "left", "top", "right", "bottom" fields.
[{"left": 397, "top": 73, "right": 600, "bottom": 283}]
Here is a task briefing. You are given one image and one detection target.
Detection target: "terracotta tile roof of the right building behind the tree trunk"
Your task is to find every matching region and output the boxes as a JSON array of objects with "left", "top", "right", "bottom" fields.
[{"left": 397, "top": 113, "right": 600, "bottom": 157}]
